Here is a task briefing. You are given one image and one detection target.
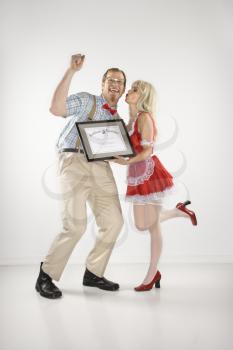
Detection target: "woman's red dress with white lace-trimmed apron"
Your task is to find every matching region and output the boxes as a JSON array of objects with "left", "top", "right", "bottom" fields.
[{"left": 126, "top": 113, "right": 174, "bottom": 203}]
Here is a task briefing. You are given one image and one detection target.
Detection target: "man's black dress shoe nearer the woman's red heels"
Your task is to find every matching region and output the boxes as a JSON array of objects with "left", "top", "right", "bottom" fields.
[{"left": 83, "top": 269, "right": 120, "bottom": 291}]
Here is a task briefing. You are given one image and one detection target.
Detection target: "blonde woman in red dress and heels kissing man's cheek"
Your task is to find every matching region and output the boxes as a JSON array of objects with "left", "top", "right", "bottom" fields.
[{"left": 114, "top": 80, "right": 197, "bottom": 291}]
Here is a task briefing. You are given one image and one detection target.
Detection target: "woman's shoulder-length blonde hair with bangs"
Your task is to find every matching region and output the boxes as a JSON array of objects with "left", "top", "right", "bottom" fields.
[{"left": 132, "top": 80, "right": 156, "bottom": 119}]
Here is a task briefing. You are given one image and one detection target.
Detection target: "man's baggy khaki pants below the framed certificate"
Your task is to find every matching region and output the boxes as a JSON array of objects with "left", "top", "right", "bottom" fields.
[{"left": 43, "top": 152, "right": 123, "bottom": 281}]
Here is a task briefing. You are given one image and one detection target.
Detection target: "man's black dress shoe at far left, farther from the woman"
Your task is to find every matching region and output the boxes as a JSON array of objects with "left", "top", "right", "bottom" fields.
[{"left": 36, "top": 262, "right": 62, "bottom": 299}]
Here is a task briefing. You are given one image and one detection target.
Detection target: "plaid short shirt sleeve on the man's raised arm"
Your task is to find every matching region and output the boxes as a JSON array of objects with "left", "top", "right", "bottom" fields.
[{"left": 66, "top": 92, "right": 91, "bottom": 117}]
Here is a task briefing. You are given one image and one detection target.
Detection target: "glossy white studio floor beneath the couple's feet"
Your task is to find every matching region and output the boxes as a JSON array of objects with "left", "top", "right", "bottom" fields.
[{"left": 0, "top": 264, "right": 233, "bottom": 350}]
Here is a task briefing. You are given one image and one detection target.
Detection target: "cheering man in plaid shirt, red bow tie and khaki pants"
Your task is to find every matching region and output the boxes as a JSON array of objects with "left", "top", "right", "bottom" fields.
[{"left": 36, "top": 54, "right": 126, "bottom": 299}]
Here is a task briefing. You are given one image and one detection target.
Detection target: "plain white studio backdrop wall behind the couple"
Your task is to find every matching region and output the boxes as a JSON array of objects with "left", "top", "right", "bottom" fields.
[{"left": 0, "top": 0, "right": 233, "bottom": 264}]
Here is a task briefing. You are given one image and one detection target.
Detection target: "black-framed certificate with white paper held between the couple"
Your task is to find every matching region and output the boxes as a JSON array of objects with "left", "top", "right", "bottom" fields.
[{"left": 75, "top": 119, "right": 135, "bottom": 162}]
